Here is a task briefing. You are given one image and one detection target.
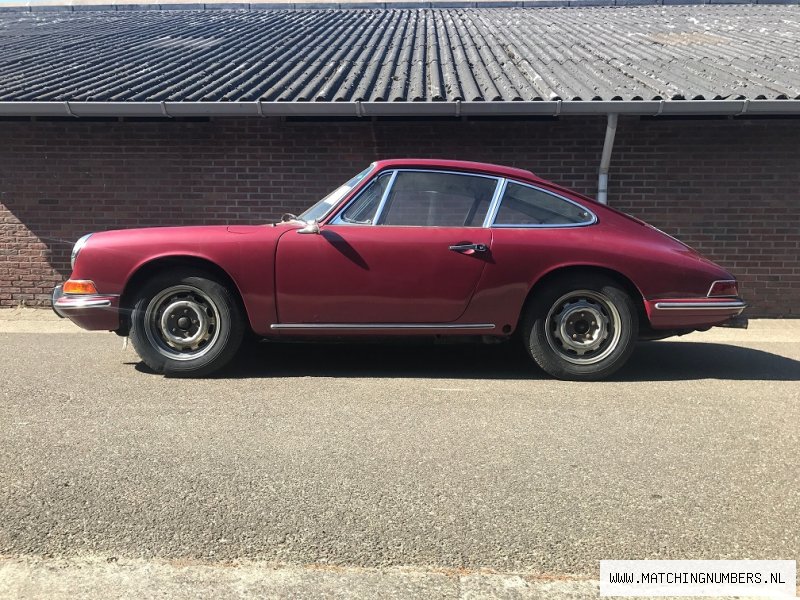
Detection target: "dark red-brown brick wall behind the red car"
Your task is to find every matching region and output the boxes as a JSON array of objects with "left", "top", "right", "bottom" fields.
[{"left": 0, "top": 118, "right": 800, "bottom": 316}]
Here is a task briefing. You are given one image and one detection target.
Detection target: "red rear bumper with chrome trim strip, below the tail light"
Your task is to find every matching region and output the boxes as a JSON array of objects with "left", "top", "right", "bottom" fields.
[{"left": 645, "top": 298, "right": 747, "bottom": 329}]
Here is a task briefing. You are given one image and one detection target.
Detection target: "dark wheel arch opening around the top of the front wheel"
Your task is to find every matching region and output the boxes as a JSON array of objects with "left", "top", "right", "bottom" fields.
[{"left": 117, "top": 255, "right": 250, "bottom": 335}]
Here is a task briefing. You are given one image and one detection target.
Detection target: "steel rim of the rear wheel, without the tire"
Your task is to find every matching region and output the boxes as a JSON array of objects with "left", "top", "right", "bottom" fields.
[{"left": 545, "top": 290, "right": 622, "bottom": 365}]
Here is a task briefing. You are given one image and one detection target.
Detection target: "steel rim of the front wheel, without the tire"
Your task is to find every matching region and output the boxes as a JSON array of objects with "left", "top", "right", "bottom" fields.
[{"left": 144, "top": 285, "right": 220, "bottom": 360}]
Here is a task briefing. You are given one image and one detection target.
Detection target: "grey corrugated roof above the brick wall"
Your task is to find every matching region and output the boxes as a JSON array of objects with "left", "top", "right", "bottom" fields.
[{"left": 0, "top": 5, "right": 800, "bottom": 102}]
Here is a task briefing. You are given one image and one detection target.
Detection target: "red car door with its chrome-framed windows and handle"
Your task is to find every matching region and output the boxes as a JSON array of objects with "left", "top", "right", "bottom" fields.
[{"left": 275, "top": 170, "right": 499, "bottom": 324}]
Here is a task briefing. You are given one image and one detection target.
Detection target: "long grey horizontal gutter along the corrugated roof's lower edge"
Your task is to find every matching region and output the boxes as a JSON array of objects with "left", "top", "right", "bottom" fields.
[{"left": 0, "top": 99, "right": 800, "bottom": 118}]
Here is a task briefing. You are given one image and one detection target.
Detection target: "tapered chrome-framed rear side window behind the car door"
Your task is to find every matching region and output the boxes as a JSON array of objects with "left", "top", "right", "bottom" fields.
[{"left": 494, "top": 181, "right": 594, "bottom": 227}]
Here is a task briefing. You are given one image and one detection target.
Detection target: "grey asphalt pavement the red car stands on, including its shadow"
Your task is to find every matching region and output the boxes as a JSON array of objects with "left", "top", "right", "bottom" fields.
[{"left": 0, "top": 311, "right": 800, "bottom": 597}]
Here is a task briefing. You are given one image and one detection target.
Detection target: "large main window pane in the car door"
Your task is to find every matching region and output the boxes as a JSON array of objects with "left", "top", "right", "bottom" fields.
[{"left": 378, "top": 171, "right": 497, "bottom": 227}]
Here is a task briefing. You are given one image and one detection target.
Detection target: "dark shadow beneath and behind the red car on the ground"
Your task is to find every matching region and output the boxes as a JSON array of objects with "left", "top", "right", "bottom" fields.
[{"left": 137, "top": 341, "right": 800, "bottom": 381}]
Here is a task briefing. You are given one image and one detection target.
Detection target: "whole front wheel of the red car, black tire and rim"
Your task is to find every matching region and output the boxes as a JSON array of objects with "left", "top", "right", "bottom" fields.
[{"left": 129, "top": 269, "right": 245, "bottom": 377}]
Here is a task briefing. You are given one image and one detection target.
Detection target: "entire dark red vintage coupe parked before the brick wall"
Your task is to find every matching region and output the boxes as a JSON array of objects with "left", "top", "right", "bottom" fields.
[{"left": 53, "top": 159, "right": 746, "bottom": 379}]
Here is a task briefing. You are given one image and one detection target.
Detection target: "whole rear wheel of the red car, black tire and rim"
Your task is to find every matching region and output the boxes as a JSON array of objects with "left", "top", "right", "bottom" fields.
[{"left": 522, "top": 275, "right": 639, "bottom": 381}]
